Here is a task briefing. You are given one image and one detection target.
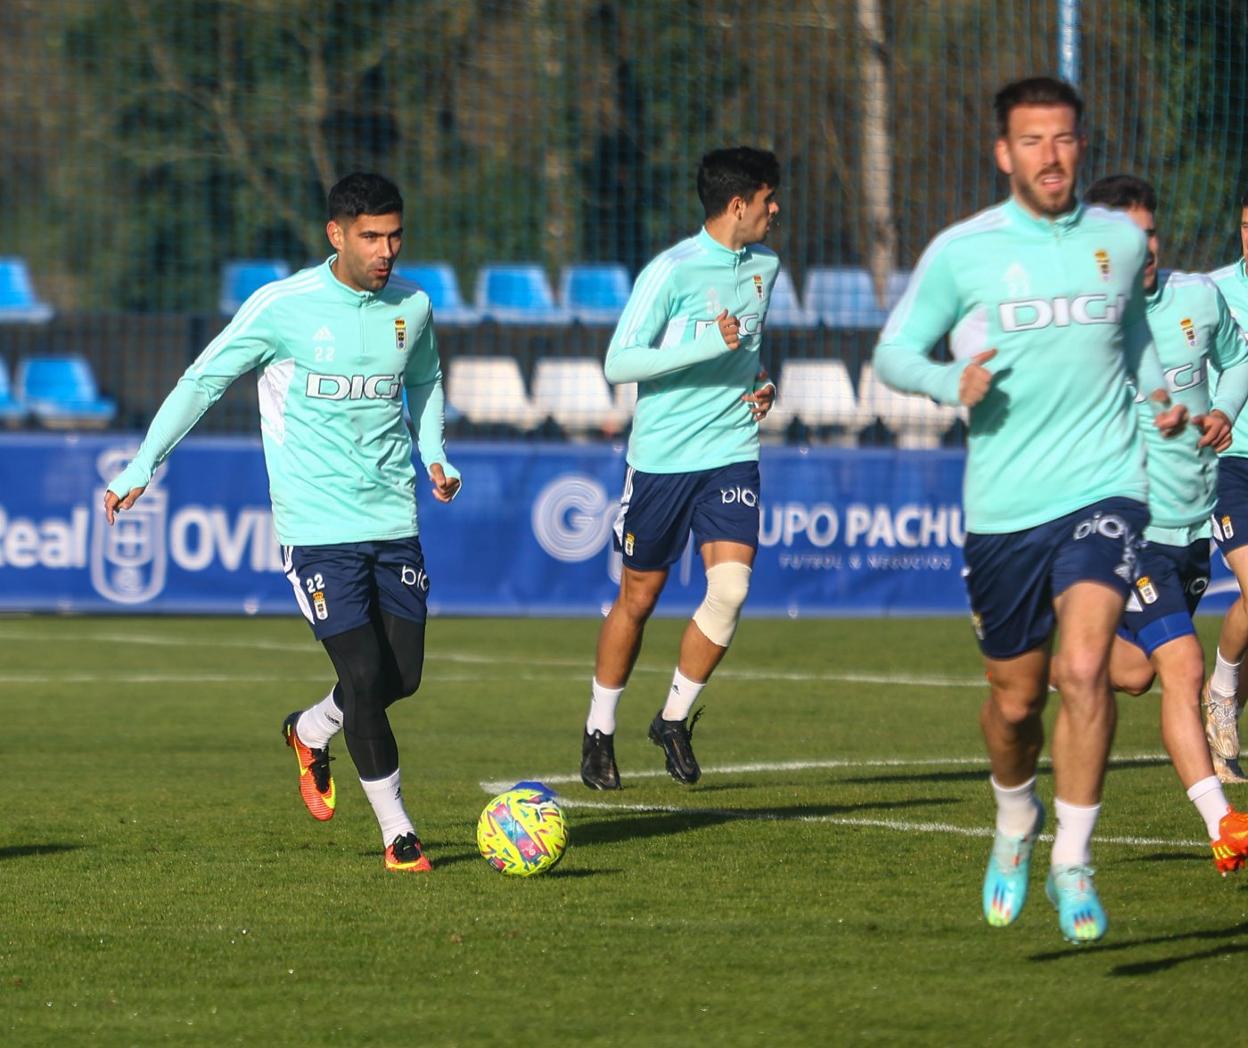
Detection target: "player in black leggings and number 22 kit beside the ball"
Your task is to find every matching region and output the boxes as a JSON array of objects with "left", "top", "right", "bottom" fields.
[{"left": 104, "top": 173, "right": 459, "bottom": 872}]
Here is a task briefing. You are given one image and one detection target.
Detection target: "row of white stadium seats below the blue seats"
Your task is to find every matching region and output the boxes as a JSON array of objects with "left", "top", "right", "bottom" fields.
[{"left": 447, "top": 356, "right": 965, "bottom": 448}]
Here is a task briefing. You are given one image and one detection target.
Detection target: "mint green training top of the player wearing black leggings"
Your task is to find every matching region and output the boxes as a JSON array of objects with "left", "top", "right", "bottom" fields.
[{"left": 109, "top": 256, "right": 458, "bottom": 545}]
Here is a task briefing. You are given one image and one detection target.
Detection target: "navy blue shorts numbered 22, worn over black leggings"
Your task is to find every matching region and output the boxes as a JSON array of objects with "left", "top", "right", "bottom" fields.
[{"left": 282, "top": 535, "right": 429, "bottom": 640}]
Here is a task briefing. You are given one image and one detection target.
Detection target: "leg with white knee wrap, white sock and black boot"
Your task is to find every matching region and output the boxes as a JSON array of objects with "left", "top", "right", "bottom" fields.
[{"left": 650, "top": 540, "right": 755, "bottom": 785}]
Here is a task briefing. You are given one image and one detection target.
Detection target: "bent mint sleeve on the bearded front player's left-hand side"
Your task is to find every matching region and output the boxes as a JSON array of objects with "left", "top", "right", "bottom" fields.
[{"left": 875, "top": 242, "right": 970, "bottom": 407}]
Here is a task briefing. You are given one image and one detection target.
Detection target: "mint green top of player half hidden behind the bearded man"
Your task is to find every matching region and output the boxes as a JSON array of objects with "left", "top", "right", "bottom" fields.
[{"left": 1137, "top": 273, "right": 1248, "bottom": 545}]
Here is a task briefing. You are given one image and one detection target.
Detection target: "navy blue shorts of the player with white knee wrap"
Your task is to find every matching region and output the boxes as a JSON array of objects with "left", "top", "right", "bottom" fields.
[{"left": 615, "top": 462, "right": 759, "bottom": 571}]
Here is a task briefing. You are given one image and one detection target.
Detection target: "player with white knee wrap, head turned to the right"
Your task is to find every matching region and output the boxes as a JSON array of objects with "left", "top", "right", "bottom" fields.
[{"left": 580, "top": 147, "right": 780, "bottom": 790}]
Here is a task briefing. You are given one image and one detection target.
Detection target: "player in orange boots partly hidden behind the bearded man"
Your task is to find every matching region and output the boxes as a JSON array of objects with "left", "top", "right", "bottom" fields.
[{"left": 1055, "top": 175, "right": 1248, "bottom": 876}]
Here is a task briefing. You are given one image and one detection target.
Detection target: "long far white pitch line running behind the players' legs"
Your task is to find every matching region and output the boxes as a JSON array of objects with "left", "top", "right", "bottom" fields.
[{"left": 0, "top": 625, "right": 985, "bottom": 687}]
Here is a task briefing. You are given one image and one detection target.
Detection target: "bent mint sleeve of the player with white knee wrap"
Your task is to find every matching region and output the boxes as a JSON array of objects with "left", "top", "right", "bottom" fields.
[{"left": 603, "top": 262, "right": 733, "bottom": 383}]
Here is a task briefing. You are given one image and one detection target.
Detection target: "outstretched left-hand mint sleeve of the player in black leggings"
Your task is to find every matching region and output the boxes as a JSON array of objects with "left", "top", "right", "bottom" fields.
[{"left": 109, "top": 299, "right": 276, "bottom": 498}]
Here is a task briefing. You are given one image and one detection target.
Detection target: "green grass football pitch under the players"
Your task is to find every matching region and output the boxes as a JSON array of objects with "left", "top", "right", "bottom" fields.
[{"left": 0, "top": 618, "right": 1248, "bottom": 1046}]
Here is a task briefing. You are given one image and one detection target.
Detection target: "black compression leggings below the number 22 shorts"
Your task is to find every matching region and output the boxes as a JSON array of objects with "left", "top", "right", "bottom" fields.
[{"left": 324, "top": 611, "right": 424, "bottom": 781}]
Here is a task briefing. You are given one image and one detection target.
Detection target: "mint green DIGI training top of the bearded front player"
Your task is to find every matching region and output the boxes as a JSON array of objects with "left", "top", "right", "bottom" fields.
[{"left": 875, "top": 198, "right": 1164, "bottom": 534}]
